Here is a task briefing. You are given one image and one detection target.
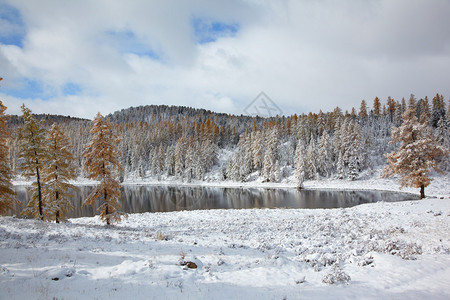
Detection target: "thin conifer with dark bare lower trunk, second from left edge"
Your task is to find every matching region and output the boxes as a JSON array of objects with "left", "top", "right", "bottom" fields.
[{"left": 19, "top": 105, "right": 48, "bottom": 220}]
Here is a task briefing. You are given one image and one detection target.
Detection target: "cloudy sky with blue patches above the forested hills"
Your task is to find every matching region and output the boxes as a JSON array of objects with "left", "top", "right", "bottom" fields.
[{"left": 0, "top": 0, "right": 450, "bottom": 119}]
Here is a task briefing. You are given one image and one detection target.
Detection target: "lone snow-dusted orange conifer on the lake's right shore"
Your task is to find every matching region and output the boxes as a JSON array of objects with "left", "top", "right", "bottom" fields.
[{"left": 383, "top": 106, "right": 445, "bottom": 198}]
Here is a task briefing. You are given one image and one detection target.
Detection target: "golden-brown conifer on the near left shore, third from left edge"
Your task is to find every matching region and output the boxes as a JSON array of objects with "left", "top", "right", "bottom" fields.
[{"left": 42, "top": 123, "right": 76, "bottom": 223}]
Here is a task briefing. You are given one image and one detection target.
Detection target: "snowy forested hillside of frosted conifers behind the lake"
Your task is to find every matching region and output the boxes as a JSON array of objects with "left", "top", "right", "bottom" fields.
[{"left": 4, "top": 94, "right": 450, "bottom": 182}]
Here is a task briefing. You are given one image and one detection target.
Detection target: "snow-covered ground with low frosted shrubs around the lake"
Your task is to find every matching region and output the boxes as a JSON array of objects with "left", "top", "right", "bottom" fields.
[{"left": 0, "top": 176, "right": 450, "bottom": 299}]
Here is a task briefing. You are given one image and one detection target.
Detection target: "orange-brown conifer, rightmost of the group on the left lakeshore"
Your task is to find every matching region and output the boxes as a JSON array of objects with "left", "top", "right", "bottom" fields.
[{"left": 83, "top": 113, "right": 123, "bottom": 225}]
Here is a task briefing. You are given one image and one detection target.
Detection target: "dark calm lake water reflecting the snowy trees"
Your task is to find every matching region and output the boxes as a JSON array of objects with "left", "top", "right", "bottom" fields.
[{"left": 9, "top": 186, "right": 418, "bottom": 218}]
